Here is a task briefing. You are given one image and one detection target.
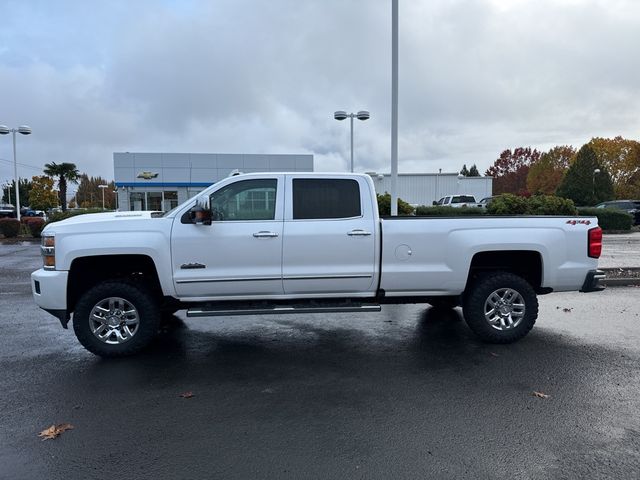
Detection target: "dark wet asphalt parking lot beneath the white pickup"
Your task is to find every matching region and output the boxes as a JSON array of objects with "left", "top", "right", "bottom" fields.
[{"left": 0, "top": 244, "right": 640, "bottom": 479}]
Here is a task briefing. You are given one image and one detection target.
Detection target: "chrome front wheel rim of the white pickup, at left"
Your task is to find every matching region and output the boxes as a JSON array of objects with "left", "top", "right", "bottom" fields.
[{"left": 89, "top": 297, "right": 140, "bottom": 345}]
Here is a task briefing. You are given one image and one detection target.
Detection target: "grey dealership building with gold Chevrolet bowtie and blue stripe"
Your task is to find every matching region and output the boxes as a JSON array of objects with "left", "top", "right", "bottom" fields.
[{"left": 113, "top": 152, "right": 313, "bottom": 211}]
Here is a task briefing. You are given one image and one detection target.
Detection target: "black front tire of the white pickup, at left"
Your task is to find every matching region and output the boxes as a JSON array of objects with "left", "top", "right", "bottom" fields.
[{"left": 73, "top": 280, "right": 160, "bottom": 358}]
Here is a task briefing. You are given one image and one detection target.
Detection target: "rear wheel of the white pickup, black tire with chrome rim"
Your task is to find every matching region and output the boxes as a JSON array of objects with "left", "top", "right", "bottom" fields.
[{"left": 463, "top": 272, "right": 538, "bottom": 343}]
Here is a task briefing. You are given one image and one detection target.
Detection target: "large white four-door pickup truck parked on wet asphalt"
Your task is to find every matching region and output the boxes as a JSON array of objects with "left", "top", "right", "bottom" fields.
[{"left": 31, "top": 173, "right": 604, "bottom": 357}]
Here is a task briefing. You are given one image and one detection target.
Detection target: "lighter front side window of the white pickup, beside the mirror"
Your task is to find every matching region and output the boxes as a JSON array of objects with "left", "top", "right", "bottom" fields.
[{"left": 210, "top": 178, "right": 278, "bottom": 221}]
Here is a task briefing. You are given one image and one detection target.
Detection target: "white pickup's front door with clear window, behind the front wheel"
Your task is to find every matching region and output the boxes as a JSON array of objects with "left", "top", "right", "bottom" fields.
[{"left": 171, "top": 175, "right": 284, "bottom": 298}]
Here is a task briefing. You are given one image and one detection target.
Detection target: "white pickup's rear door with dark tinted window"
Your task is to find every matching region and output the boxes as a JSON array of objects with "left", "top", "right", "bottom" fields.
[{"left": 282, "top": 175, "right": 377, "bottom": 295}]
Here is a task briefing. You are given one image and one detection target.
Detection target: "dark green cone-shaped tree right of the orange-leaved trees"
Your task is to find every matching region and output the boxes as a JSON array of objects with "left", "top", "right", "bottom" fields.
[{"left": 556, "top": 144, "right": 614, "bottom": 206}]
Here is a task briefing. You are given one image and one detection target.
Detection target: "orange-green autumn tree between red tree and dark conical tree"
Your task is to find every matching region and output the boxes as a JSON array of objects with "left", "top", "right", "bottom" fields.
[{"left": 527, "top": 145, "right": 576, "bottom": 195}]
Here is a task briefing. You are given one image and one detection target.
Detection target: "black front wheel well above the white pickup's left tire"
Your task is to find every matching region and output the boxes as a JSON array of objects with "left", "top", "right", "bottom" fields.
[{"left": 67, "top": 255, "right": 162, "bottom": 312}]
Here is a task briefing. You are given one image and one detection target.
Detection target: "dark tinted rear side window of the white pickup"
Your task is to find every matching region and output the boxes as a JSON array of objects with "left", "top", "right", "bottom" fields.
[{"left": 293, "top": 178, "right": 362, "bottom": 220}]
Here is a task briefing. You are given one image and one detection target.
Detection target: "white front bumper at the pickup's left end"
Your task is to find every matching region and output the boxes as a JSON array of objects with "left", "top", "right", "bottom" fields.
[{"left": 31, "top": 268, "right": 69, "bottom": 328}]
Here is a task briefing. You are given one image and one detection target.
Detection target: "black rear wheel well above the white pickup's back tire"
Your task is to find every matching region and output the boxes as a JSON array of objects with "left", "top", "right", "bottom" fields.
[{"left": 467, "top": 250, "right": 542, "bottom": 291}]
